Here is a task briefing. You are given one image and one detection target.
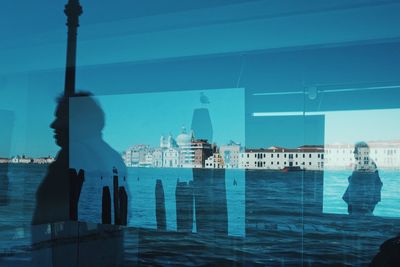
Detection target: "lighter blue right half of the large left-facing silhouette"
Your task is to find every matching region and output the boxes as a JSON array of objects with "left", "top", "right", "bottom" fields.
[{"left": 69, "top": 93, "right": 129, "bottom": 224}]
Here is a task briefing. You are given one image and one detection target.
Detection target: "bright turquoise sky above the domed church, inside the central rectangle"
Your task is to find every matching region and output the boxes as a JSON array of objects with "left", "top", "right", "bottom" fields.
[{"left": 93, "top": 88, "right": 245, "bottom": 152}]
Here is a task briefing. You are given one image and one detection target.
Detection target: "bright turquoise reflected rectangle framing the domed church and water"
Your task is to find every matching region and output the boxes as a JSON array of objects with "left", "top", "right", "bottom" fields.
[{"left": 86, "top": 88, "right": 245, "bottom": 236}]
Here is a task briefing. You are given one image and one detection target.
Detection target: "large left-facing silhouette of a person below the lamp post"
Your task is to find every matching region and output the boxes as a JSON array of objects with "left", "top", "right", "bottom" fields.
[{"left": 32, "top": 93, "right": 126, "bottom": 224}]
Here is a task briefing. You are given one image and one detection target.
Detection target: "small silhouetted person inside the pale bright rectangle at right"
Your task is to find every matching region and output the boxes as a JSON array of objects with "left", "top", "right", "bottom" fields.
[{"left": 343, "top": 142, "right": 382, "bottom": 215}]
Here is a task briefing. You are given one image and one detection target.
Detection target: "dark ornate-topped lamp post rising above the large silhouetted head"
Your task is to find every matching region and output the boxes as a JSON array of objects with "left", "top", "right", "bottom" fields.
[{"left": 64, "top": 0, "right": 82, "bottom": 97}]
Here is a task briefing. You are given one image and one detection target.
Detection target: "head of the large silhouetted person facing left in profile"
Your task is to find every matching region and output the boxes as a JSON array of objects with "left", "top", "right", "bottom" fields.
[{"left": 50, "top": 92, "right": 104, "bottom": 148}]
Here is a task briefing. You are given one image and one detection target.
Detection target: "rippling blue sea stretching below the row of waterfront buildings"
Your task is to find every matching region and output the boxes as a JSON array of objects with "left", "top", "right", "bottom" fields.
[{"left": 0, "top": 164, "right": 400, "bottom": 266}]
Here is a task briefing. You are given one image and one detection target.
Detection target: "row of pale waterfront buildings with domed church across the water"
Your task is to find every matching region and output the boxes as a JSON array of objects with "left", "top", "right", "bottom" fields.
[{"left": 123, "top": 129, "right": 400, "bottom": 170}]
